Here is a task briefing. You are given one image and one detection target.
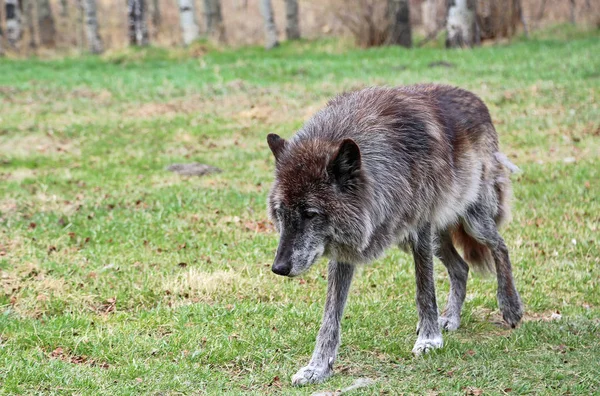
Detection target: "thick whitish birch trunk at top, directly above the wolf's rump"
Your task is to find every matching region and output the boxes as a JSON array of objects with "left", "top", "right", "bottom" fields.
[{"left": 446, "top": 0, "right": 479, "bottom": 48}]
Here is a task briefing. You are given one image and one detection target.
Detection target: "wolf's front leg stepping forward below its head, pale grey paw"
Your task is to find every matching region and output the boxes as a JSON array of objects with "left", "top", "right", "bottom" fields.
[{"left": 292, "top": 260, "right": 354, "bottom": 385}]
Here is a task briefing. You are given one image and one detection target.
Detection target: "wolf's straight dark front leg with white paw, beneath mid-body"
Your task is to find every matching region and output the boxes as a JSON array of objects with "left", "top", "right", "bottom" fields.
[{"left": 411, "top": 225, "right": 444, "bottom": 355}]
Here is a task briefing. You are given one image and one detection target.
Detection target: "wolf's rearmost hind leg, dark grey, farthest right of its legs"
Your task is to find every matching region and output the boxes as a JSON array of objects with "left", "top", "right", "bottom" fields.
[{"left": 463, "top": 205, "right": 523, "bottom": 328}]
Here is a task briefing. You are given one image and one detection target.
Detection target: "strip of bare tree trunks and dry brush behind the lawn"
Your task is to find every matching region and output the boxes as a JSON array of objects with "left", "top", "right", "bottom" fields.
[{"left": 0, "top": 0, "right": 600, "bottom": 55}]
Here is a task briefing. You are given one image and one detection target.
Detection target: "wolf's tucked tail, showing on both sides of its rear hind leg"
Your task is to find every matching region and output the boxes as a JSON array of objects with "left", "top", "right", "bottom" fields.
[{"left": 451, "top": 152, "right": 520, "bottom": 273}]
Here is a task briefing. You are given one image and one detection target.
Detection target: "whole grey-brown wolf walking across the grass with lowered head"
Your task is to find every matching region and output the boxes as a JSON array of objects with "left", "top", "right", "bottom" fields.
[{"left": 267, "top": 84, "right": 523, "bottom": 385}]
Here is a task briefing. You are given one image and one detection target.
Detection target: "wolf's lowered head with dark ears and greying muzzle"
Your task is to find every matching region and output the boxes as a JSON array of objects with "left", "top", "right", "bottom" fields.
[{"left": 267, "top": 134, "right": 365, "bottom": 277}]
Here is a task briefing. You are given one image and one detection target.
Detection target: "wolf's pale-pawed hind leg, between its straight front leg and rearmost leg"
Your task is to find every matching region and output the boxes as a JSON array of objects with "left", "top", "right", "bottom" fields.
[{"left": 436, "top": 231, "right": 469, "bottom": 331}]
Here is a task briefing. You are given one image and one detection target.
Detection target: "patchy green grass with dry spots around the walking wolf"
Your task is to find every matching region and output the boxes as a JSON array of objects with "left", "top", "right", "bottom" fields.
[{"left": 0, "top": 27, "right": 600, "bottom": 395}]
